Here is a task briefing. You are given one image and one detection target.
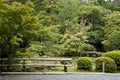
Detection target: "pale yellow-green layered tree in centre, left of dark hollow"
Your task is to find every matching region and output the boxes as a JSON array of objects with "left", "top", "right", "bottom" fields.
[{"left": 61, "top": 22, "right": 94, "bottom": 57}]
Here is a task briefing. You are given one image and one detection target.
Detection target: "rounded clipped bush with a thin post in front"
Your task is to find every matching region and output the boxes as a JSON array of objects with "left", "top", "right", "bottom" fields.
[{"left": 95, "top": 57, "right": 117, "bottom": 72}]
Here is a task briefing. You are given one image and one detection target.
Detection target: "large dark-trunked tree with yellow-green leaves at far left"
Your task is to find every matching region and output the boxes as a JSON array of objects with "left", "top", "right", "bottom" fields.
[{"left": 0, "top": 1, "right": 37, "bottom": 57}]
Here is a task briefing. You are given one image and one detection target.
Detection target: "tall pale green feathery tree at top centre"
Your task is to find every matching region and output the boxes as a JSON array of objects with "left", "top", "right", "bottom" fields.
[{"left": 52, "top": 0, "right": 79, "bottom": 34}]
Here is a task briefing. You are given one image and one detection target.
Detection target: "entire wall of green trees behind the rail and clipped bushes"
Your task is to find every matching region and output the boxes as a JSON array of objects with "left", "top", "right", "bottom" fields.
[{"left": 0, "top": 0, "right": 120, "bottom": 57}]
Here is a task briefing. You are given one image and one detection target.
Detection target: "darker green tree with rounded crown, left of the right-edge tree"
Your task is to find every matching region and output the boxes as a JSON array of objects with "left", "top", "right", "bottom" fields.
[{"left": 79, "top": 4, "right": 106, "bottom": 51}]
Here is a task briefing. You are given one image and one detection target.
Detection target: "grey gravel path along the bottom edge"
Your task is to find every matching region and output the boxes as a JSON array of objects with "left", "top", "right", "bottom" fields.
[{"left": 0, "top": 73, "right": 120, "bottom": 80}]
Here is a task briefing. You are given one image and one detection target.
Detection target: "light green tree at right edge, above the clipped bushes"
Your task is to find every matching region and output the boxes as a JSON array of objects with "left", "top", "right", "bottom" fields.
[{"left": 102, "top": 12, "right": 120, "bottom": 51}]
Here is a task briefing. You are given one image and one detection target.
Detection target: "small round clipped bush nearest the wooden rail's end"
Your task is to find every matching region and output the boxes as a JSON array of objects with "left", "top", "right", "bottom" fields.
[{"left": 77, "top": 57, "right": 92, "bottom": 70}]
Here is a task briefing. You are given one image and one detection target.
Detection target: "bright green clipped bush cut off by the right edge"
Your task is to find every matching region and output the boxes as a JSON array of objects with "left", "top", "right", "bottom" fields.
[{"left": 102, "top": 50, "right": 120, "bottom": 70}]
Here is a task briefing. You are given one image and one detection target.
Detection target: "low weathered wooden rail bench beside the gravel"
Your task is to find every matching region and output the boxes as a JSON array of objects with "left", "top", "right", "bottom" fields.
[{"left": 0, "top": 58, "right": 72, "bottom": 72}]
